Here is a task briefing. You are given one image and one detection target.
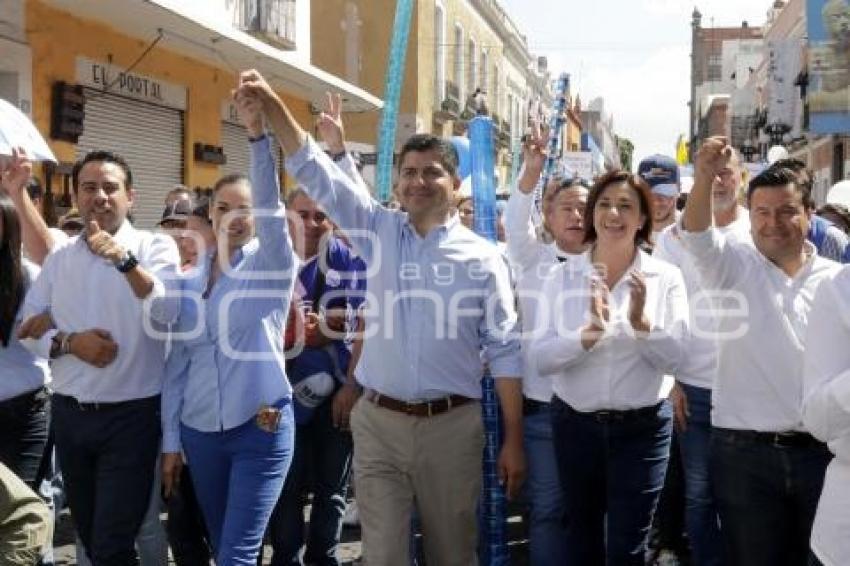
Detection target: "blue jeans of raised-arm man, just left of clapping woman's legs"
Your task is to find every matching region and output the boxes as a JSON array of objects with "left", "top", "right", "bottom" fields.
[{"left": 523, "top": 403, "right": 567, "bottom": 566}]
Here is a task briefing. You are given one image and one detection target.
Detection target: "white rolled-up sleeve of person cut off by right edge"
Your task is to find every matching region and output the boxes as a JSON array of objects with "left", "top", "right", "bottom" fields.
[{"left": 803, "top": 268, "right": 850, "bottom": 446}]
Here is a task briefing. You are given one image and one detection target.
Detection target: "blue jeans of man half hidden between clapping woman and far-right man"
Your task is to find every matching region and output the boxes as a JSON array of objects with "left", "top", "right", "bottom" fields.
[{"left": 678, "top": 383, "right": 723, "bottom": 566}]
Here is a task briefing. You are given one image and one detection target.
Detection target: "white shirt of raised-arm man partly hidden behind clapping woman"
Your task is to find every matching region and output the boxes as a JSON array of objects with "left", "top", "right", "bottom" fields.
[{"left": 505, "top": 190, "right": 584, "bottom": 403}]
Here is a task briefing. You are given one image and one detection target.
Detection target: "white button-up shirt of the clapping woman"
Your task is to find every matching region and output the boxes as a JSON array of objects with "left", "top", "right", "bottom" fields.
[{"left": 531, "top": 251, "right": 688, "bottom": 411}]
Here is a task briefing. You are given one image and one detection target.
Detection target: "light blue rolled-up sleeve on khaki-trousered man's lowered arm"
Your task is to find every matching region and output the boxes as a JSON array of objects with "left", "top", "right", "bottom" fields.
[{"left": 481, "top": 255, "right": 523, "bottom": 379}]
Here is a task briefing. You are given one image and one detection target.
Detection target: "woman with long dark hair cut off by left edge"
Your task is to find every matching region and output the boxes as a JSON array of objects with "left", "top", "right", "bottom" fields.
[{"left": 0, "top": 192, "right": 50, "bottom": 489}]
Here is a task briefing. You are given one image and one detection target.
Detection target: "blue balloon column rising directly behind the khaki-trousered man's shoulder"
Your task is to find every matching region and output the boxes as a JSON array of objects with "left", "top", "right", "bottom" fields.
[{"left": 469, "top": 116, "right": 510, "bottom": 566}]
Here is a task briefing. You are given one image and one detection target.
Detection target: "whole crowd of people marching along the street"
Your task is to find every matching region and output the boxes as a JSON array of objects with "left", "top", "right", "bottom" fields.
[{"left": 0, "top": 67, "right": 850, "bottom": 566}]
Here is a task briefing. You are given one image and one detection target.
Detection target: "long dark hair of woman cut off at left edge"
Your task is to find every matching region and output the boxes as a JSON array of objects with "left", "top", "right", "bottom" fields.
[{"left": 0, "top": 193, "right": 26, "bottom": 347}]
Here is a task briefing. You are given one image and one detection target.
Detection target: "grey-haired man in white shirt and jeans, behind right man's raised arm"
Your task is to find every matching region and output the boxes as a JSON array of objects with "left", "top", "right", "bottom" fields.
[{"left": 653, "top": 152, "right": 752, "bottom": 566}]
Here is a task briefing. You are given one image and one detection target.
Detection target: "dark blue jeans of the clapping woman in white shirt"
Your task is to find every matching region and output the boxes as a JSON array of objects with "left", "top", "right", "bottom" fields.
[{"left": 551, "top": 398, "right": 673, "bottom": 566}]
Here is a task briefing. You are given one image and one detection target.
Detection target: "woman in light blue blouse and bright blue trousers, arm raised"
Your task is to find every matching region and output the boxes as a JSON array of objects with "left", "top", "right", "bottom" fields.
[{"left": 163, "top": 81, "right": 297, "bottom": 565}]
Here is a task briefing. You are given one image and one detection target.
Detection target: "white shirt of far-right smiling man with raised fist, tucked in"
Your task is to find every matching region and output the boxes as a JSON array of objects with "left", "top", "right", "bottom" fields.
[{"left": 682, "top": 228, "right": 839, "bottom": 432}]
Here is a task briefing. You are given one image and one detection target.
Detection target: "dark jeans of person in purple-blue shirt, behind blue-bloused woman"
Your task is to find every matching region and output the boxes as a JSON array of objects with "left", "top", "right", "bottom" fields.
[{"left": 269, "top": 397, "right": 351, "bottom": 566}]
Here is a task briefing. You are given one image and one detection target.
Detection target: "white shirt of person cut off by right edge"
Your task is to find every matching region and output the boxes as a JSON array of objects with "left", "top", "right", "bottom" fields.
[{"left": 803, "top": 267, "right": 850, "bottom": 566}]
